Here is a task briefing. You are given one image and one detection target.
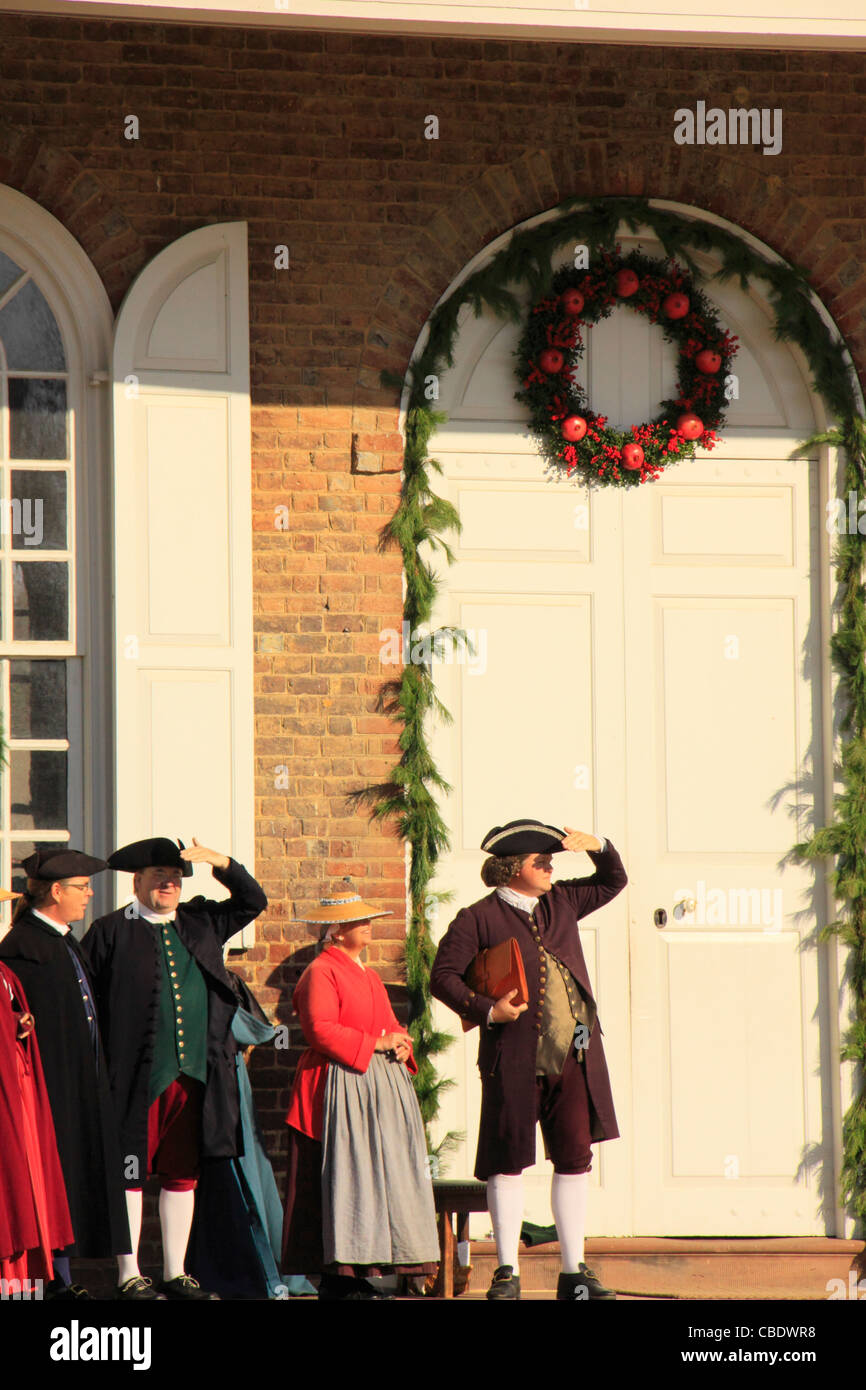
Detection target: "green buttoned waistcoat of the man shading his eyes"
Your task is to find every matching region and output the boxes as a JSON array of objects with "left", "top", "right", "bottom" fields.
[{"left": 149, "top": 922, "right": 207, "bottom": 1101}]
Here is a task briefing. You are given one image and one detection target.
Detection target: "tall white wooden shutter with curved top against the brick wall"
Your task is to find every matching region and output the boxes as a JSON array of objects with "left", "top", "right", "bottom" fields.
[{"left": 113, "top": 222, "right": 254, "bottom": 945}]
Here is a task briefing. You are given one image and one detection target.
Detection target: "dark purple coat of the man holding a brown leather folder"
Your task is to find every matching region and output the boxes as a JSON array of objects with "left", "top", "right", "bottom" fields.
[{"left": 430, "top": 841, "right": 628, "bottom": 1182}]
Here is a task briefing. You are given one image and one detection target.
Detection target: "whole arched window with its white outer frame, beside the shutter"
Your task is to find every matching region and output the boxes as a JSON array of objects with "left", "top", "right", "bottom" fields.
[{"left": 0, "top": 193, "right": 114, "bottom": 911}]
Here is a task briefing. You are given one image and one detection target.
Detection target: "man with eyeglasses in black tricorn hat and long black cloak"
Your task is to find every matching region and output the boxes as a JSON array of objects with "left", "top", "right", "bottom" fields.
[{"left": 0, "top": 845, "right": 131, "bottom": 1300}]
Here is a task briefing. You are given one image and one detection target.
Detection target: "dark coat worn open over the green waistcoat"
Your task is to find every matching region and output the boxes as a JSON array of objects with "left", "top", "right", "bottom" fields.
[{"left": 82, "top": 859, "right": 267, "bottom": 1187}]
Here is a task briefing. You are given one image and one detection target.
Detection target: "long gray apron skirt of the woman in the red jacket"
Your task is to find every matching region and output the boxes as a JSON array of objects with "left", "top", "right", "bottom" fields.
[{"left": 321, "top": 1052, "right": 439, "bottom": 1265}]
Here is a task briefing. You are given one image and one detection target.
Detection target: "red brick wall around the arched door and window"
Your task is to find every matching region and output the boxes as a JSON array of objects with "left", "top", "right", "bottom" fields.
[{"left": 0, "top": 15, "right": 866, "bottom": 1206}]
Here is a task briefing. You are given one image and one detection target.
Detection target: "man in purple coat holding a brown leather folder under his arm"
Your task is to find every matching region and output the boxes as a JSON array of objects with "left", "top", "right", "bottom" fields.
[{"left": 431, "top": 817, "right": 628, "bottom": 1301}]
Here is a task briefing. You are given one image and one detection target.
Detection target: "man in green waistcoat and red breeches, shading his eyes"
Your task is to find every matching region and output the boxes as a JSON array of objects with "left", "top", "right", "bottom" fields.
[{"left": 82, "top": 837, "right": 267, "bottom": 1301}]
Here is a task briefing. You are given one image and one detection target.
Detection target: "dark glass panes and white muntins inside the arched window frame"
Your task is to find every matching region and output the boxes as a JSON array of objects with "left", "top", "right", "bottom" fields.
[{"left": 0, "top": 241, "right": 82, "bottom": 885}]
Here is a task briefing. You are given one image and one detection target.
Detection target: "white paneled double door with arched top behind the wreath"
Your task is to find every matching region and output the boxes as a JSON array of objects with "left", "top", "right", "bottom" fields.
[{"left": 431, "top": 227, "right": 831, "bottom": 1234}]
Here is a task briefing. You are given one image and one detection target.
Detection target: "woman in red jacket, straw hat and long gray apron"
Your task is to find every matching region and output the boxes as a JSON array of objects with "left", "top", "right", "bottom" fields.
[{"left": 282, "top": 891, "right": 439, "bottom": 1300}]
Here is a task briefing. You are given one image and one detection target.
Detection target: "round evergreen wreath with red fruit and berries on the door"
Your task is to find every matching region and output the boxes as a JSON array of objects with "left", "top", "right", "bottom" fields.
[{"left": 514, "top": 247, "right": 737, "bottom": 488}]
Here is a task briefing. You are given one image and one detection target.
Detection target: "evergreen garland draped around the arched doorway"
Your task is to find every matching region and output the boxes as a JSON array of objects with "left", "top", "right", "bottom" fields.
[{"left": 352, "top": 197, "right": 866, "bottom": 1223}]
